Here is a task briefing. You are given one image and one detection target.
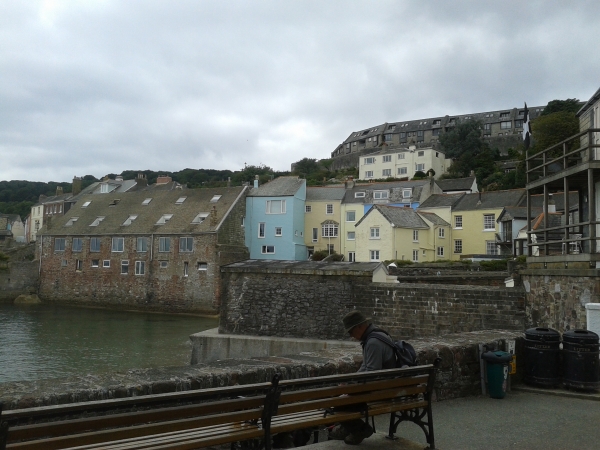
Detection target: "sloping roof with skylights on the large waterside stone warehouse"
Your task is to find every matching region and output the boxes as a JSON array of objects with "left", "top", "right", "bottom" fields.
[{"left": 39, "top": 186, "right": 247, "bottom": 235}]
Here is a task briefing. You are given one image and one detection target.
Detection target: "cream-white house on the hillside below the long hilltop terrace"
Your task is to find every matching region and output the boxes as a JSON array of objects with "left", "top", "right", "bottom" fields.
[{"left": 358, "top": 145, "right": 450, "bottom": 180}]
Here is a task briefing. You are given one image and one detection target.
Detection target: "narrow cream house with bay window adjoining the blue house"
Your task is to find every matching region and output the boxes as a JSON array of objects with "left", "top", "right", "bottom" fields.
[{"left": 304, "top": 186, "right": 346, "bottom": 257}]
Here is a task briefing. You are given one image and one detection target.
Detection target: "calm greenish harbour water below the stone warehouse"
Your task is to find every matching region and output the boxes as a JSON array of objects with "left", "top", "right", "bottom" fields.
[{"left": 0, "top": 304, "right": 218, "bottom": 383}]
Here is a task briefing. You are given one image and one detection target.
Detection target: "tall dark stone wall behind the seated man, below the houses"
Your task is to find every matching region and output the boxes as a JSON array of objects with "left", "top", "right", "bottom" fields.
[{"left": 219, "top": 267, "right": 524, "bottom": 339}]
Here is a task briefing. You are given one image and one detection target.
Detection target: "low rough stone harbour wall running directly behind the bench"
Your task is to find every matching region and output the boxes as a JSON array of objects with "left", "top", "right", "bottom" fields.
[{"left": 0, "top": 330, "right": 523, "bottom": 409}]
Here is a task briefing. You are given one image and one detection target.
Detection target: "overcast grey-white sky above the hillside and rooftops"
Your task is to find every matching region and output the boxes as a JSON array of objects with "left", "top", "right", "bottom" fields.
[{"left": 0, "top": 0, "right": 600, "bottom": 181}]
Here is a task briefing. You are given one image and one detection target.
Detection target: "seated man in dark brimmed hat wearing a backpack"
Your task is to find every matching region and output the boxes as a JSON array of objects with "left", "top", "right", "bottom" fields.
[{"left": 329, "top": 310, "right": 396, "bottom": 445}]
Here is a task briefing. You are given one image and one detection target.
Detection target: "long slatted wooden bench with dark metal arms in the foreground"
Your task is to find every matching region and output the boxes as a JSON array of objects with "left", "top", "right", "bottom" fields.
[{"left": 0, "top": 365, "right": 435, "bottom": 450}]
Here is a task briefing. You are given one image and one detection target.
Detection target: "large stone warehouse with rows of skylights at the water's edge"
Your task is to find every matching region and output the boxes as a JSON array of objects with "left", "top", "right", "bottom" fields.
[{"left": 37, "top": 186, "right": 248, "bottom": 314}]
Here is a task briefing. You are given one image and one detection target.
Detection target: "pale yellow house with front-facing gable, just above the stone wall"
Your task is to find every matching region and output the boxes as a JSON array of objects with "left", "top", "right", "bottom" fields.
[{"left": 355, "top": 205, "right": 452, "bottom": 262}]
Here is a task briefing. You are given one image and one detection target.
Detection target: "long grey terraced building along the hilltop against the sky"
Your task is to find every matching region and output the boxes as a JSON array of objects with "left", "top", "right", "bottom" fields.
[{"left": 331, "top": 106, "right": 544, "bottom": 170}]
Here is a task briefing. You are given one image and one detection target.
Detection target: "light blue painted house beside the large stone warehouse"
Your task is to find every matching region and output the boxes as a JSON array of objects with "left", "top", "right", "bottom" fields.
[{"left": 245, "top": 177, "right": 307, "bottom": 261}]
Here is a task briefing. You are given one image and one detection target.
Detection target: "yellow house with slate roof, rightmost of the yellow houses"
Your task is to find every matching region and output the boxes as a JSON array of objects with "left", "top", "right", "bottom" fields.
[{"left": 449, "top": 189, "right": 525, "bottom": 260}]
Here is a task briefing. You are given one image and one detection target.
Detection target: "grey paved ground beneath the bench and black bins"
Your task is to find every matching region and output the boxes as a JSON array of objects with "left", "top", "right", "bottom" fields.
[{"left": 304, "top": 389, "right": 600, "bottom": 450}]
